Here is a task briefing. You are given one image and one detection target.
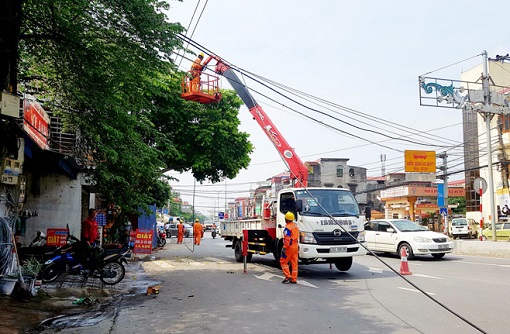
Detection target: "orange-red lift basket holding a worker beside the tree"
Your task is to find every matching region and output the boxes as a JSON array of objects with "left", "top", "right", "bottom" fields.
[{"left": 181, "top": 72, "right": 221, "bottom": 104}]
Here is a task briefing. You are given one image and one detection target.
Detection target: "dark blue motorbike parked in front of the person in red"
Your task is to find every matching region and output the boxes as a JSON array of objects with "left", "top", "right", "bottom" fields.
[{"left": 40, "top": 234, "right": 130, "bottom": 285}]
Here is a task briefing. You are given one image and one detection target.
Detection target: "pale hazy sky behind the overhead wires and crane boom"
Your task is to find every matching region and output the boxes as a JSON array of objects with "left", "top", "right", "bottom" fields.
[{"left": 162, "top": 0, "right": 510, "bottom": 218}]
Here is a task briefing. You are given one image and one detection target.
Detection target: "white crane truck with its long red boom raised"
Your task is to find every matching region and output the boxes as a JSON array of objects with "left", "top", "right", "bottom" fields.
[{"left": 183, "top": 55, "right": 366, "bottom": 271}]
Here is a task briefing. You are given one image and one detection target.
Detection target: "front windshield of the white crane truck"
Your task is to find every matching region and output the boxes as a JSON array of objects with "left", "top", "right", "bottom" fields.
[{"left": 296, "top": 189, "right": 359, "bottom": 217}]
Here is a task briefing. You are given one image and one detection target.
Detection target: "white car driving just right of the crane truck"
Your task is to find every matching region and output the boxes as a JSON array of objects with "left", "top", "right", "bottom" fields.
[{"left": 365, "top": 219, "right": 453, "bottom": 259}]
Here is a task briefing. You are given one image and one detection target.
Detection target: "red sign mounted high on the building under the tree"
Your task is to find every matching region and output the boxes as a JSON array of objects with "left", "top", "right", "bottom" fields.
[{"left": 23, "top": 99, "right": 50, "bottom": 150}]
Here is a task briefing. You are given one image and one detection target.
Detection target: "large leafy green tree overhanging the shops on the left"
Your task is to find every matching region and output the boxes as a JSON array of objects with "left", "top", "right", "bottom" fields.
[{"left": 0, "top": 0, "right": 252, "bottom": 212}]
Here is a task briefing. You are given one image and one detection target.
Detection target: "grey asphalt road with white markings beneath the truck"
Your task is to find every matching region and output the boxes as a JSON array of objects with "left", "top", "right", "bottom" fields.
[{"left": 28, "top": 234, "right": 510, "bottom": 334}]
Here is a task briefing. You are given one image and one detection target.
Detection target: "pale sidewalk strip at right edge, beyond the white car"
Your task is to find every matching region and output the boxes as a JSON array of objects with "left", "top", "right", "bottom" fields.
[{"left": 453, "top": 239, "right": 510, "bottom": 258}]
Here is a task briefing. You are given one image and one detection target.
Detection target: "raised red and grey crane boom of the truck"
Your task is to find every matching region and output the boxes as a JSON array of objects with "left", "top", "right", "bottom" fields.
[{"left": 214, "top": 57, "right": 308, "bottom": 187}]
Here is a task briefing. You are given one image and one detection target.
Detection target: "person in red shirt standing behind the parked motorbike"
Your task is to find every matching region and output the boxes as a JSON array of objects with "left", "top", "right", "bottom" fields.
[{"left": 78, "top": 208, "right": 100, "bottom": 271}]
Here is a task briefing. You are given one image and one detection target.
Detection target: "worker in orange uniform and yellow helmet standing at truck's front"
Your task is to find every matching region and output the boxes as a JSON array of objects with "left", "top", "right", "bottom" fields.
[{"left": 280, "top": 211, "right": 299, "bottom": 284}]
